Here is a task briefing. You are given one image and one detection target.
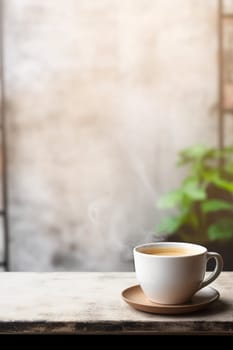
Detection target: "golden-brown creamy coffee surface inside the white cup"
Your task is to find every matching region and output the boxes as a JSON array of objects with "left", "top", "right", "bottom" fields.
[{"left": 140, "top": 246, "right": 196, "bottom": 256}]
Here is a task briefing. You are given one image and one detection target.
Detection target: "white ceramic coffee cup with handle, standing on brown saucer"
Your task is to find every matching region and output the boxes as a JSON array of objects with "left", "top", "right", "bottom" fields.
[{"left": 133, "top": 242, "right": 223, "bottom": 304}]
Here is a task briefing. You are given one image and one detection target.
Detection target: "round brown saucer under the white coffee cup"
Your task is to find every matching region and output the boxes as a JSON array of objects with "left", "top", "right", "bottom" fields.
[{"left": 121, "top": 285, "right": 219, "bottom": 315}]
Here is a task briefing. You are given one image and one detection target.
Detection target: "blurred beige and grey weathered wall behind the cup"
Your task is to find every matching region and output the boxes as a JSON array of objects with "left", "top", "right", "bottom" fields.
[{"left": 1, "top": 0, "right": 224, "bottom": 271}]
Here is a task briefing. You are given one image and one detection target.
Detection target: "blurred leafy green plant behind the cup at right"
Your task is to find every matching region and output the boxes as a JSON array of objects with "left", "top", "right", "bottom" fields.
[{"left": 156, "top": 145, "right": 233, "bottom": 270}]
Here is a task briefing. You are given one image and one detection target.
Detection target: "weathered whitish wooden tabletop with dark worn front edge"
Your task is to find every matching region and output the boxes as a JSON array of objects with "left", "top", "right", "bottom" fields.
[{"left": 0, "top": 272, "right": 233, "bottom": 335}]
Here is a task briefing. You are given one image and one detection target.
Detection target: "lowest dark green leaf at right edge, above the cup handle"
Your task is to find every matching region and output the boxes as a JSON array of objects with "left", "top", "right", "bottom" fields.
[{"left": 208, "top": 218, "right": 233, "bottom": 241}]
